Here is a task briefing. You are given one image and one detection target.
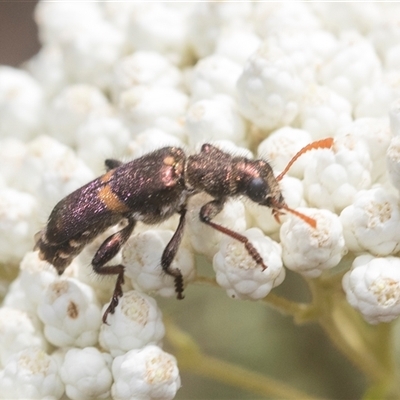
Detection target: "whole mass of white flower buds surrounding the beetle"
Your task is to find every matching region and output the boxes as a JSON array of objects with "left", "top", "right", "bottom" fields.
[{"left": 0, "top": 1, "right": 400, "bottom": 400}]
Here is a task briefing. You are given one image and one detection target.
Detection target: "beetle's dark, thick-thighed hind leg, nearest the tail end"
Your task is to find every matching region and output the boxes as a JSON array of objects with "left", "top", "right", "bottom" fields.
[{"left": 92, "top": 218, "right": 136, "bottom": 323}]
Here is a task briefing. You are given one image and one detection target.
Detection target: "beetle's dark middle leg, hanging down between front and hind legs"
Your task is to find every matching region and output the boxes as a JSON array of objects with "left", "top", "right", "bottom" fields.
[{"left": 161, "top": 208, "right": 186, "bottom": 299}]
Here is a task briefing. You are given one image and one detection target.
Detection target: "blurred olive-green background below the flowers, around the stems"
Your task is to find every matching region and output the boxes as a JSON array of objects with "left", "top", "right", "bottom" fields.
[{"left": 159, "top": 255, "right": 366, "bottom": 399}]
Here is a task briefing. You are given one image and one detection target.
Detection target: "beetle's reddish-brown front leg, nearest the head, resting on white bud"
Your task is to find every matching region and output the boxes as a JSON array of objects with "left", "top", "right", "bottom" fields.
[{"left": 199, "top": 199, "right": 267, "bottom": 270}]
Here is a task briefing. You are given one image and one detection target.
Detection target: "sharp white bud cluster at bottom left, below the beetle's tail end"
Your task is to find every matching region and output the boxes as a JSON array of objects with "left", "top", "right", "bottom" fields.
[{"left": 0, "top": 252, "right": 180, "bottom": 399}]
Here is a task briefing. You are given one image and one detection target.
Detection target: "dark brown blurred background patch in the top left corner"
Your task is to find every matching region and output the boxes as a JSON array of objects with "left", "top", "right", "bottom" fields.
[{"left": 0, "top": 0, "right": 39, "bottom": 66}]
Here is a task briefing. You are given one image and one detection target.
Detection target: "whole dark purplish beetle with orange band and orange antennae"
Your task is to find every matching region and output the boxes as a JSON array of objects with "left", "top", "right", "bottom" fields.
[{"left": 35, "top": 138, "right": 333, "bottom": 322}]
